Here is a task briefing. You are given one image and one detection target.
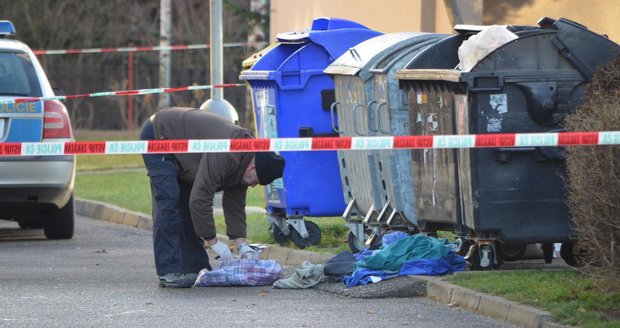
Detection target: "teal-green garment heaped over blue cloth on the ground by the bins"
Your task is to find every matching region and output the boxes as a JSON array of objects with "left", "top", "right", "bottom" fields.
[{"left": 355, "top": 234, "right": 450, "bottom": 271}]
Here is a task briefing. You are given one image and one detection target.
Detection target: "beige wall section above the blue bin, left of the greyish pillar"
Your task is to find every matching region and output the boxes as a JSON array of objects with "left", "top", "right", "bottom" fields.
[{"left": 269, "top": 0, "right": 452, "bottom": 41}]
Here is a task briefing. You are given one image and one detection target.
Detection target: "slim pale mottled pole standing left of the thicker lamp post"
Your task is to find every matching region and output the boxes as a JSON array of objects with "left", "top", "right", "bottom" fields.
[{"left": 159, "top": 0, "right": 172, "bottom": 108}]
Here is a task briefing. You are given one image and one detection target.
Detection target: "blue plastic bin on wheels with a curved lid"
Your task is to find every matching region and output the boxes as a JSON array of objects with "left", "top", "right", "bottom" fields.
[{"left": 240, "top": 18, "right": 381, "bottom": 248}]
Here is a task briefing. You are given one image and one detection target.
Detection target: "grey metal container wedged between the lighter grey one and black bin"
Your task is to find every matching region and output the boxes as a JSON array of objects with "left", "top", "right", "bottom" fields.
[{"left": 369, "top": 35, "right": 463, "bottom": 234}]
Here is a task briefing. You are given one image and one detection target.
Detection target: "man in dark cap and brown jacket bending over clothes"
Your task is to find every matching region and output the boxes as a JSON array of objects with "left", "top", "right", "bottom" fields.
[{"left": 140, "top": 107, "right": 284, "bottom": 288}]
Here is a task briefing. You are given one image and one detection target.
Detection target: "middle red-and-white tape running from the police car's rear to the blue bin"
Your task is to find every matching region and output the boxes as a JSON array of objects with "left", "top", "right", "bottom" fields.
[{"left": 0, "top": 83, "right": 245, "bottom": 105}]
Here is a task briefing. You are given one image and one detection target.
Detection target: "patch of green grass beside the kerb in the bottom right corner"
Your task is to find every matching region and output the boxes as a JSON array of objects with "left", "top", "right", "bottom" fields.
[{"left": 444, "top": 269, "right": 620, "bottom": 327}]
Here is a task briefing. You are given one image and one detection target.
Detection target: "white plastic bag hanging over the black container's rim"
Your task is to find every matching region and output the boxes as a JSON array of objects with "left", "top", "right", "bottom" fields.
[{"left": 459, "top": 25, "right": 518, "bottom": 72}]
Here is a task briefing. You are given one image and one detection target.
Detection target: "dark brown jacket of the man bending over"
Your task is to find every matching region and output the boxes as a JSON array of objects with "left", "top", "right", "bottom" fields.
[{"left": 153, "top": 107, "right": 254, "bottom": 238}]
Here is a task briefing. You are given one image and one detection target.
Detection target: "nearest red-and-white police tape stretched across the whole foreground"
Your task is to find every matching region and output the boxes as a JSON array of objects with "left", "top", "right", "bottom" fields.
[{"left": 0, "top": 131, "right": 620, "bottom": 156}]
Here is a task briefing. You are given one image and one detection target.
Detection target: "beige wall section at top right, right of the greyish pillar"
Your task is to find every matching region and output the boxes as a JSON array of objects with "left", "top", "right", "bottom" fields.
[{"left": 483, "top": 0, "right": 620, "bottom": 42}]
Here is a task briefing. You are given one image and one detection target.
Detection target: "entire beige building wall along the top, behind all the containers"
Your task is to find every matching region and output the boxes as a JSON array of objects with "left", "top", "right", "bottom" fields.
[{"left": 269, "top": 0, "right": 620, "bottom": 42}]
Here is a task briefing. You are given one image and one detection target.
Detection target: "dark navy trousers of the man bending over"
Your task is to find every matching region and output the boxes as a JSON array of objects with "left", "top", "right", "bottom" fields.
[{"left": 140, "top": 120, "right": 211, "bottom": 276}]
